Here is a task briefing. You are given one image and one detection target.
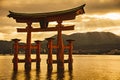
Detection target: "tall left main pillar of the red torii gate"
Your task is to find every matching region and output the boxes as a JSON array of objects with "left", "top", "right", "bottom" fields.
[{"left": 25, "top": 22, "right": 32, "bottom": 71}]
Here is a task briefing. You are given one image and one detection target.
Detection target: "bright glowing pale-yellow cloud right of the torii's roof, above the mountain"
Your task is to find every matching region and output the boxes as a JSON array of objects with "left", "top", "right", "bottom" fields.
[{"left": 75, "top": 13, "right": 120, "bottom": 28}]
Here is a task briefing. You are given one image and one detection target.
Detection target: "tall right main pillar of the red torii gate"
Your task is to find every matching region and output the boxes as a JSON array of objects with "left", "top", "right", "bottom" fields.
[{"left": 56, "top": 20, "right": 64, "bottom": 70}]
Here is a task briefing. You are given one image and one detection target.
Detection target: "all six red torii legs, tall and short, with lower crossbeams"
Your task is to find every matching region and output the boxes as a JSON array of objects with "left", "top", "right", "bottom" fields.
[{"left": 13, "top": 21, "right": 73, "bottom": 71}]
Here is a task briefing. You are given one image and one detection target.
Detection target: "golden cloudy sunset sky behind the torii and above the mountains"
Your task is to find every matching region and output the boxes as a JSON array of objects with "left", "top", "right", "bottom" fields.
[{"left": 0, "top": 0, "right": 120, "bottom": 41}]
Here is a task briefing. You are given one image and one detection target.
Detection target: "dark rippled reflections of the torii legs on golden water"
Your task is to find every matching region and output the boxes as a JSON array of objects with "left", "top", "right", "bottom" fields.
[{"left": 11, "top": 70, "right": 73, "bottom": 80}]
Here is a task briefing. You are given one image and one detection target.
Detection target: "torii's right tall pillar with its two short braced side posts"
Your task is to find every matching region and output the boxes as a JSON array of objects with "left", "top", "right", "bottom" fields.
[{"left": 47, "top": 21, "right": 73, "bottom": 71}]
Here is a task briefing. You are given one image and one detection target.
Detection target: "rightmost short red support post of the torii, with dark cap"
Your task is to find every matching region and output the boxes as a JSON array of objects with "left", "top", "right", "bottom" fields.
[{"left": 67, "top": 39, "right": 74, "bottom": 70}]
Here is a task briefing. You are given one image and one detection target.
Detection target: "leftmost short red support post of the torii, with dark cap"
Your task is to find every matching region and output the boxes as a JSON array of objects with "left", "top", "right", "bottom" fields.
[{"left": 12, "top": 39, "right": 20, "bottom": 71}]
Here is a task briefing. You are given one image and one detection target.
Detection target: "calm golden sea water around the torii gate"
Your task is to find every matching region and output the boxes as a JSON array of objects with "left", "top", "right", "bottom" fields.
[{"left": 0, "top": 55, "right": 120, "bottom": 80}]
